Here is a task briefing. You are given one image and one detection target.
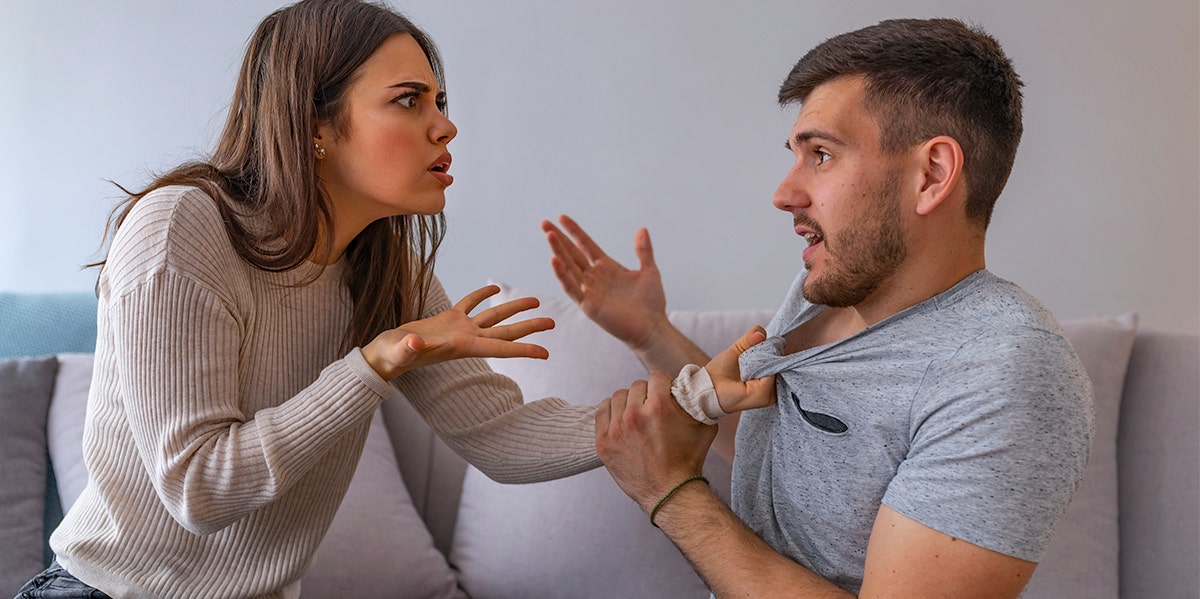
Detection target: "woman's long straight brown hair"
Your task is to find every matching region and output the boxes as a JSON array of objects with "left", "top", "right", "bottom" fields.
[{"left": 94, "top": 0, "right": 445, "bottom": 349}]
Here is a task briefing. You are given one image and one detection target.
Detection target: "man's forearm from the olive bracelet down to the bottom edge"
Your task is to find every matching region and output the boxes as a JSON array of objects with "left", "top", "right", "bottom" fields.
[{"left": 654, "top": 483, "right": 853, "bottom": 599}]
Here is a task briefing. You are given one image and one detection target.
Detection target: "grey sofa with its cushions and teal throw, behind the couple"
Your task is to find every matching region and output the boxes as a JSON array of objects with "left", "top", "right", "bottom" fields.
[{"left": 0, "top": 289, "right": 1200, "bottom": 599}]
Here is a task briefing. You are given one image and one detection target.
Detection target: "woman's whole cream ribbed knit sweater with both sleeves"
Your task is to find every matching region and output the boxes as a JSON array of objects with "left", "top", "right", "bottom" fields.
[{"left": 50, "top": 186, "right": 599, "bottom": 598}]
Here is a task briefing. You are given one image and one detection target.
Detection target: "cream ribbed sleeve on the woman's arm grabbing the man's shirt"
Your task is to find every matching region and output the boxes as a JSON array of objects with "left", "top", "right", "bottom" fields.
[{"left": 394, "top": 278, "right": 600, "bottom": 483}]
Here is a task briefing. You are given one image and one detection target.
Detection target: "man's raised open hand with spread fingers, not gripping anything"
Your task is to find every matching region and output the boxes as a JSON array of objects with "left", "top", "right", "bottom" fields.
[{"left": 541, "top": 215, "right": 667, "bottom": 351}]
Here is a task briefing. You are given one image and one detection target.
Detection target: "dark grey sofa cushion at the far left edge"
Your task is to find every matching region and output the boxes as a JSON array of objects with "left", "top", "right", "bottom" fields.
[{"left": 0, "top": 357, "right": 58, "bottom": 597}]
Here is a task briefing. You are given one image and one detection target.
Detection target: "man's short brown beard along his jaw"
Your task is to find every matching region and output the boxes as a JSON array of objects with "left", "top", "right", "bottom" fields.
[{"left": 802, "top": 173, "right": 908, "bottom": 307}]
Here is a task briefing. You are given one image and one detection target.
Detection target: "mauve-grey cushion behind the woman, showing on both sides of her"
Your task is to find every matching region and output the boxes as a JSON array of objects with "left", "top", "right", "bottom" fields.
[{"left": 46, "top": 354, "right": 462, "bottom": 599}]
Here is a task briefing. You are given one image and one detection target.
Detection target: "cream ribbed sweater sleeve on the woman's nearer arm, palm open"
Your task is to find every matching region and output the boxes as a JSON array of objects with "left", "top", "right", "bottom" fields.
[{"left": 102, "top": 187, "right": 391, "bottom": 534}]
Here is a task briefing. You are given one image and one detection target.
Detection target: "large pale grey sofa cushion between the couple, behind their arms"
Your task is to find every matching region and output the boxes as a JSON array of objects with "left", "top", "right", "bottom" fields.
[{"left": 450, "top": 286, "right": 772, "bottom": 599}]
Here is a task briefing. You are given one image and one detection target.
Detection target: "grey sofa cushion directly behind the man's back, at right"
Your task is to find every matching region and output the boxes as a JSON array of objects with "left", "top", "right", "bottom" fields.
[{"left": 1024, "top": 315, "right": 1138, "bottom": 599}]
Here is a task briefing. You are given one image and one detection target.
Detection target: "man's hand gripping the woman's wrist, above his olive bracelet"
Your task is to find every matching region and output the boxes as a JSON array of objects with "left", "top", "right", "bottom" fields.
[{"left": 596, "top": 372, "right": 716, "bottom": 514}]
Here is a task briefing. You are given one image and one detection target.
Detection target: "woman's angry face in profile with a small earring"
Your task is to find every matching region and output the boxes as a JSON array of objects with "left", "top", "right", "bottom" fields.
[{"left": 314, "top": 34, "right": 458, "bottom": 233}]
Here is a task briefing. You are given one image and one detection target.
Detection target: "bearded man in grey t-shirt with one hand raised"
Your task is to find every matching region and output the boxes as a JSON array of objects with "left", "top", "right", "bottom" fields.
[{"left": 542, "top": 19, "right": 1093, "bottom": 598}]
